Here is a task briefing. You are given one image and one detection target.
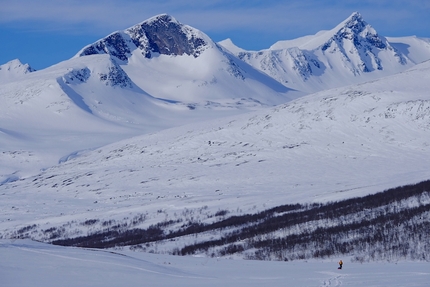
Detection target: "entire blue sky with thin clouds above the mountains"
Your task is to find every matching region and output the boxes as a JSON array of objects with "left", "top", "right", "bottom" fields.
[{"left": 0, "top": 0, "right": 430, "bottom": 69}]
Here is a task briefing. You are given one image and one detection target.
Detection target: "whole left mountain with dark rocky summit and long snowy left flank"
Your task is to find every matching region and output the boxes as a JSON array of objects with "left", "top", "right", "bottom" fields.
[{"left": 0, "top": 14, "right": 303, "bottom": 183}]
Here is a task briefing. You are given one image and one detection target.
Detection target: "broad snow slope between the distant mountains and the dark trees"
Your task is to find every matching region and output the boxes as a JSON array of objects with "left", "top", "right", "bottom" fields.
[{"left": 0, "top": 58, "right": 430, "bottom": 243}]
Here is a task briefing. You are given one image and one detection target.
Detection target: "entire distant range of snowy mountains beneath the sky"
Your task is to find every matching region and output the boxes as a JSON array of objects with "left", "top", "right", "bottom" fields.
[{"left": 0, "top": 13, "right": 430, "bottom": 182}]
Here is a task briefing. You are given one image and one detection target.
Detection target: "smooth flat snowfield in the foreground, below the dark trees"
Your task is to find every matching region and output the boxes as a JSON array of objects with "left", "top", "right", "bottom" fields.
[{"left": 0, "top": 240, "right": 430, "bottom": 287}]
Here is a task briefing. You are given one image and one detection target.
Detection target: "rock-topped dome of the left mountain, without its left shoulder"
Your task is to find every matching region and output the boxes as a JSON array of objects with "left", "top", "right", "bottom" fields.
[{"left": 76, "top": 14, "right": 296, "bottom": 106}]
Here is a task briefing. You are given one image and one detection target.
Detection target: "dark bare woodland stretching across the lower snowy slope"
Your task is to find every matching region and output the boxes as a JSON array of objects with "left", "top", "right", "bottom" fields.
[{"left": 50, "top": 180, "right": 430, "bottom": 261}]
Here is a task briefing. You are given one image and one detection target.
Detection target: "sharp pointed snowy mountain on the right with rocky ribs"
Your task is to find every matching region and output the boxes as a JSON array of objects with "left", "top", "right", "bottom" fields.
[{"left": 220, "top": 12, "right": 430, "bottom": 92}]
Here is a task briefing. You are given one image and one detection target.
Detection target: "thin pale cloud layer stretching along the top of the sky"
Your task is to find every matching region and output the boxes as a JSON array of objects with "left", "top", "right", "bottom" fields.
[{"left": 0, "top": 0, "right": 430, "bottom": 37}]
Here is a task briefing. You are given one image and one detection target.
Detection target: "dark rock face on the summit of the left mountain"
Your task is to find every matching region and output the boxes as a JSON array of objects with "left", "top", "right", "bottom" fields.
[{"left": 79, "top": 14, "right": 207, "bottom": 62}]
